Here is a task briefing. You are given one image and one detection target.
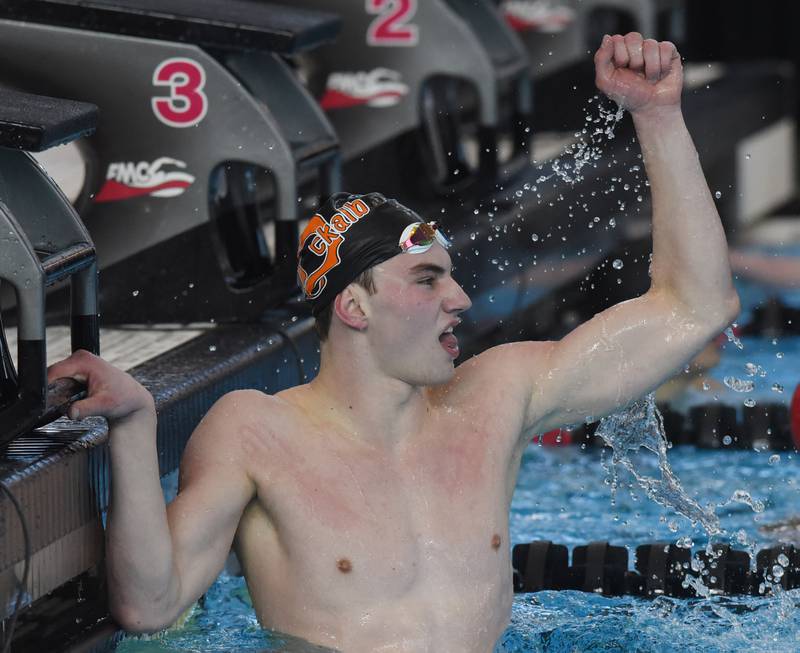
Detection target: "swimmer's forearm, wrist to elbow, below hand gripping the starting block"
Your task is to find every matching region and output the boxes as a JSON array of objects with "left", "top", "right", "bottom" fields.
[{"left": 106, "top": 411, "right": 179, "bottom": 630}]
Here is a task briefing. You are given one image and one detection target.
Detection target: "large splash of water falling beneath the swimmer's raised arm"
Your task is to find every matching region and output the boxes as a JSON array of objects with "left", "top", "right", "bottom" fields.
[{"left": 596, "top": 394, "right": 722, "bottom": 535}]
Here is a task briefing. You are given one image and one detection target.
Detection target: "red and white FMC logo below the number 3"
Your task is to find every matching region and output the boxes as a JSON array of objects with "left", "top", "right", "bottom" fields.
[{"left": 94, "top": 156, "right": 194, "bottom": 202}]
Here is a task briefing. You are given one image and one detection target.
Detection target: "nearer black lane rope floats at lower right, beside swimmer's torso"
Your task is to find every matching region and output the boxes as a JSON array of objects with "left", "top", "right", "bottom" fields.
[{"left": 512, "top": 540, "right": 800, "bottom": 598}]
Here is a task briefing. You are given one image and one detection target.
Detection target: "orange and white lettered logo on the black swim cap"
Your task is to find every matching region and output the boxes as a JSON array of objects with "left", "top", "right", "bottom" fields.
[{"left": 297, "top": 199, "right": 370, "bottom": 299}]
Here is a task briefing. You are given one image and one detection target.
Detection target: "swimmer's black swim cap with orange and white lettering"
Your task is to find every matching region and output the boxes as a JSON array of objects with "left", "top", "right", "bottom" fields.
[{"left": 297, "top": 193, "right": 423, "bottom": 316}]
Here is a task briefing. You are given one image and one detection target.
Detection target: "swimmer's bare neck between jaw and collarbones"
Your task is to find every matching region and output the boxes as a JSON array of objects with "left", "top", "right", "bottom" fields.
[{"left": 308, "top": 339, "right": 428, "bottom": 447}]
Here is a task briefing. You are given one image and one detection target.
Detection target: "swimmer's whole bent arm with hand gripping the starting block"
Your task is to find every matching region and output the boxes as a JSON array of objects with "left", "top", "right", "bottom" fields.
[{"left": 48, "top": 352, "right": 254, "bottom": 632}]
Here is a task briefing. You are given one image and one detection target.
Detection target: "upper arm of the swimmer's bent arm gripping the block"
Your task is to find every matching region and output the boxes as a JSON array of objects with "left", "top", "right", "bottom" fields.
[{"left": 167, "top": 398, "right": 255, "bottom": 608}]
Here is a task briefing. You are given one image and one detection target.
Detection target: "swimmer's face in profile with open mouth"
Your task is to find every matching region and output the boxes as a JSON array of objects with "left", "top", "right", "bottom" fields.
[{"left": 360, "top": 243, "right": 472, "bottom": 385}]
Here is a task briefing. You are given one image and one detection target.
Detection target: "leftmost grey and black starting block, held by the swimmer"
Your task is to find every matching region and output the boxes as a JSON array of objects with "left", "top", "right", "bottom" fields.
[{"left": 0, "top": 89, "right": 99, "bottom": 444}]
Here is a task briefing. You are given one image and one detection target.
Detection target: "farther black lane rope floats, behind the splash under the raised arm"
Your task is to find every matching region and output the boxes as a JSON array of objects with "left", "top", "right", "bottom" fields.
[{"left": 533, "top": 403, "right": 795, "bottom": 451}]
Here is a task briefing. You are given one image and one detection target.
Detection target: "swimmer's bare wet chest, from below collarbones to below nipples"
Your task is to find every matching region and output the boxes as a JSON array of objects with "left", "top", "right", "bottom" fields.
[{"left": 237, "top": 420, "right": 508, "bottom": 602}]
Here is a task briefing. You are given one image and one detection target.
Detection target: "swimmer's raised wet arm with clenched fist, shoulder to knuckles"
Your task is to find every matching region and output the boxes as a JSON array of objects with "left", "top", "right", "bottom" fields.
[{"left": 512, "top": 33, "right": 739, "bottom": 431}]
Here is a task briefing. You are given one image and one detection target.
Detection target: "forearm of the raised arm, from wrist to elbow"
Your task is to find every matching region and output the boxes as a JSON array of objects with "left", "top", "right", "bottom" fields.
[{"left": 633, "top": 106, "right": 738, "bottom": 322}]
